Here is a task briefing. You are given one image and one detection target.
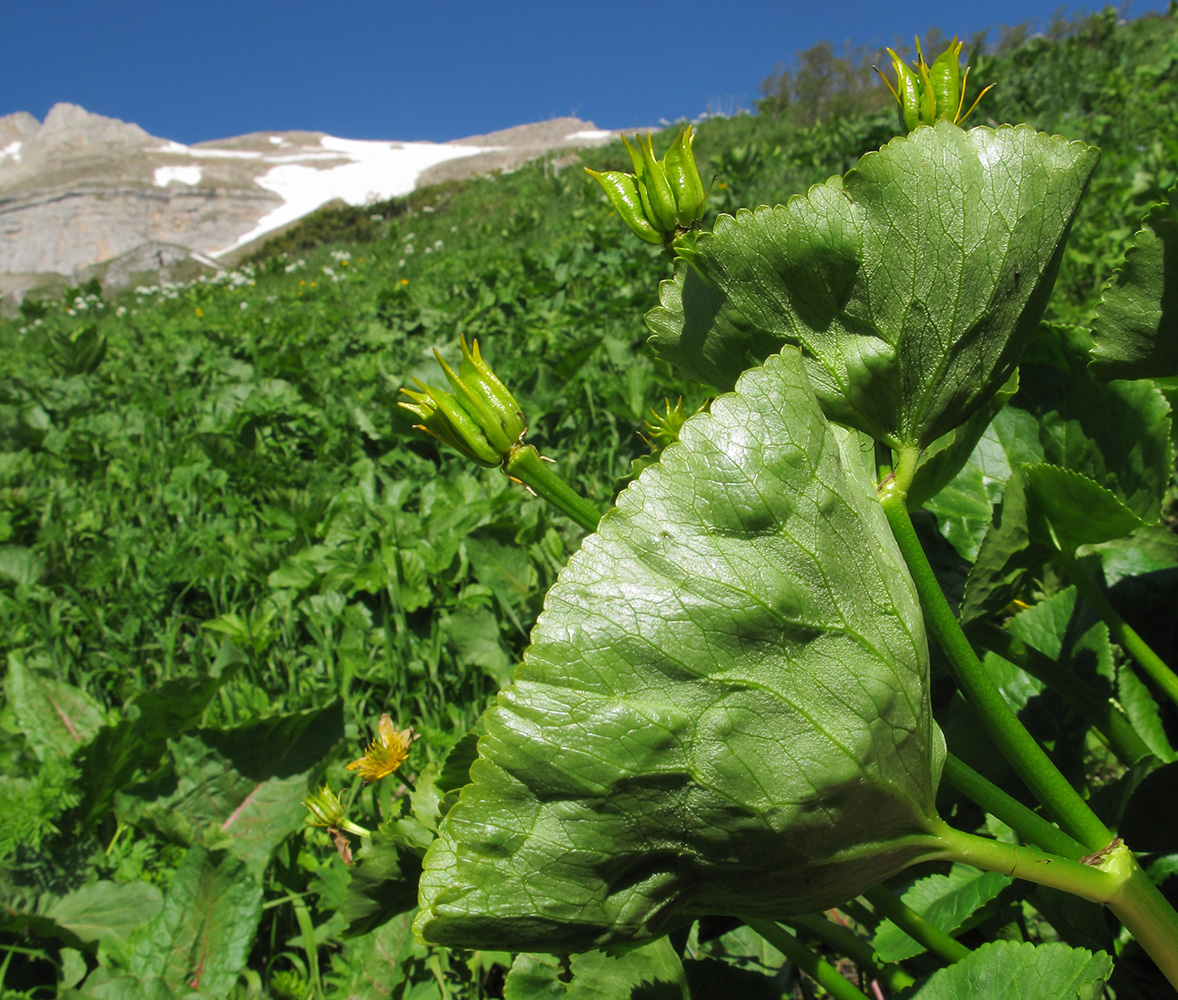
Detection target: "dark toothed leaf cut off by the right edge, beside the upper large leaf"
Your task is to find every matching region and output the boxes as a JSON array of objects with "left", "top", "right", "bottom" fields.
[{"left": 1092, "top": 188, "right": 1178, "bottom": 379}]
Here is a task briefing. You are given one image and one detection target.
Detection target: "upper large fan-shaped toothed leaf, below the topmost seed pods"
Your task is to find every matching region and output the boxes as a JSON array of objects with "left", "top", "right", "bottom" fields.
[{"left": 647, "top": 121, "right": 1099, "bottom": 446}]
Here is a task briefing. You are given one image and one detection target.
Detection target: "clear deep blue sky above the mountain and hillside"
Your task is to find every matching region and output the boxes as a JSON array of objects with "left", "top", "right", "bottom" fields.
[{"left": 0, "top": 0, "right": 1165, "bottom": 143}]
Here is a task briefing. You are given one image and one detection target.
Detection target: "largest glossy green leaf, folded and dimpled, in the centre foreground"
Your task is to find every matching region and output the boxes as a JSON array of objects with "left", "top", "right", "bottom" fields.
[{"left": 416, "top": 350, "right": 942, "bottom": 952}]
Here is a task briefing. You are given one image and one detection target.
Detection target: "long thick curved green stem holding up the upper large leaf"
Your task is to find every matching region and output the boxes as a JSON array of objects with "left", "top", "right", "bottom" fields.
[{"left": 880, "top": 479, "right": 1112, "bottom": 850}]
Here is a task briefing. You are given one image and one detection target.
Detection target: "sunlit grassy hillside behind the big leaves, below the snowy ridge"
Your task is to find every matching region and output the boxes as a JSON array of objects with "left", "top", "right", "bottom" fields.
[{"left": 0, "top": 13, "right": 1178, "bottom": 998}]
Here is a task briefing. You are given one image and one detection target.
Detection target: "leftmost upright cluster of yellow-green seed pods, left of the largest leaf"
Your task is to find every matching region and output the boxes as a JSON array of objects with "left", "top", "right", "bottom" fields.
[{"left": 399, "top": 338, "right": 528, "bottom": 468}]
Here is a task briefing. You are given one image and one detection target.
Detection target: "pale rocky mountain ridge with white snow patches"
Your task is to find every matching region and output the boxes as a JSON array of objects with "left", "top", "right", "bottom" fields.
[{"left": 0, "top": 104, "right": 616, "bottom": 297}]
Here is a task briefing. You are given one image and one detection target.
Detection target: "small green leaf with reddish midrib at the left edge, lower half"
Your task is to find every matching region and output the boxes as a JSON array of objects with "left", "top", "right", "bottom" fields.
[{"left": 5, "top": 653, "right": 104, "bottom": 761}]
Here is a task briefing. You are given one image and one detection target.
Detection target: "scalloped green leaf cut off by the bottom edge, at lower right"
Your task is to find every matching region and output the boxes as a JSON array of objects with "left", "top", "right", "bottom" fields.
[{"left": 898, "top": 941, "right": 1112, "bottom": 1000}]
